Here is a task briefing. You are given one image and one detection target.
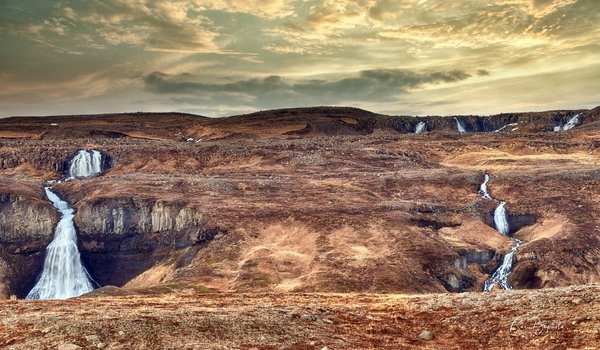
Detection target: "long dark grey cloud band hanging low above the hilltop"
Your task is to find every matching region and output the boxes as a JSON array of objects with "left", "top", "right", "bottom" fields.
[{"left": 144, "top": 69, "right": 470, "bottom": 107}]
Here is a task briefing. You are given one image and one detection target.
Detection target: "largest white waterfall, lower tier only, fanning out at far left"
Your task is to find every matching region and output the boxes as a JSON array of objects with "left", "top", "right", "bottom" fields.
[{"left": 26, "top": 187, "right": 94, "bottom": 299}]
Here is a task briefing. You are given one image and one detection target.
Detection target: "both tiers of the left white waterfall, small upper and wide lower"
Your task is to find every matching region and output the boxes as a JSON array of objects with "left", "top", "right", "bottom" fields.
[{"left": 26, "top": 150, "right": 102, "bottom": 299}]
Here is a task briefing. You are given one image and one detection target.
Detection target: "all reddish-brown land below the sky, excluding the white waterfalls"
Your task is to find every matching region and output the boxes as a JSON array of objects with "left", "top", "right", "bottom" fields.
[{"left": 0, "top": 107, "right": 600, "bottom": 349}]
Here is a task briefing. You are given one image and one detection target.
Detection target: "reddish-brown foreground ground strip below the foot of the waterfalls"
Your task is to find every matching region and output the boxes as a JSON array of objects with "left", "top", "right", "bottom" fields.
[{"left": 0, "top": 285, "right": 600, "bottom": 350}]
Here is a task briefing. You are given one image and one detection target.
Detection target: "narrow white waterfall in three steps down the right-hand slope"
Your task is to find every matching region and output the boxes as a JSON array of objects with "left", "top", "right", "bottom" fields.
[{"left": 479, "top": 173, "right": 523, "bottom": 292}]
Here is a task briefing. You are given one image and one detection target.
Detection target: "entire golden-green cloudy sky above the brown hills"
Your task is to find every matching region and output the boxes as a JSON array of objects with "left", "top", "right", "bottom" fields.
[{"left": 0, "top": 0, "right": 600, "bottom": 117}]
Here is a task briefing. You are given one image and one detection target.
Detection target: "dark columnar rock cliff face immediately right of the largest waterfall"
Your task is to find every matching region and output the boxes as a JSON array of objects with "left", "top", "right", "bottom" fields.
[{"left": 75, "top": 197, "right": 219, "bottom": 286}]
